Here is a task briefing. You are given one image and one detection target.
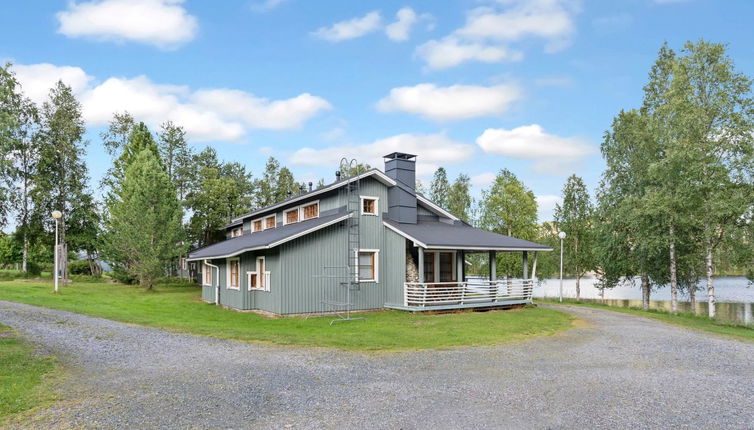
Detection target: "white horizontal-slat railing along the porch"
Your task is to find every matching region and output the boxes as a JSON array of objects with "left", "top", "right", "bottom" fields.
[{"left": 403, "top": 279, "right": 534, "bottom": 308}]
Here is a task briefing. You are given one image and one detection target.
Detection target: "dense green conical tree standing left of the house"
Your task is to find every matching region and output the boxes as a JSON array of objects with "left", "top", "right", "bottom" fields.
[{"left": 106, "top": 148, "right": 185, "bottom": 288}]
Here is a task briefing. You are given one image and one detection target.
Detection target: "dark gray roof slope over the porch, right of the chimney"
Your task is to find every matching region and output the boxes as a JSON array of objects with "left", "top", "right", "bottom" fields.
[{"left": 383, "top": 219, "right": 552, "bottom": 251}]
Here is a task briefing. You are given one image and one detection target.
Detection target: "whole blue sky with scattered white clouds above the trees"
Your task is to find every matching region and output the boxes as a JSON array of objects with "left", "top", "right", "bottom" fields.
[{"left": 0, "top": 0, "right": 754, "bottom": 220}]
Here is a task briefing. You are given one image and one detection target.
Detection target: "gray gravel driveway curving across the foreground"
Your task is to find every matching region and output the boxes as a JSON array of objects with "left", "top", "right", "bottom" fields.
[{"left": 0, "top": 302, "right": 754, "bottom": 429}]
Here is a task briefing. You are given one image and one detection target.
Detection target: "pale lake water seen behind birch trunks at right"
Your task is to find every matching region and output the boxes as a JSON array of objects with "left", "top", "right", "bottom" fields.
[{"left": 533, "top": 276, "right": 754, "bottom": 324}]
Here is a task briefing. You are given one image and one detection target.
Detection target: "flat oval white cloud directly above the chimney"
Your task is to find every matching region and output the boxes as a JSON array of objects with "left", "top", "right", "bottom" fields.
[{"left": 377, "top": 84, "right": 521, "bottom": 121}]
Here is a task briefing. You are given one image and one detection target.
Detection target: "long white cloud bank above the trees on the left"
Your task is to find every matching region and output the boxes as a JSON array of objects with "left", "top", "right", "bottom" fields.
[{"left": 14, "top": 64, "right": 331, "bottom": 141}]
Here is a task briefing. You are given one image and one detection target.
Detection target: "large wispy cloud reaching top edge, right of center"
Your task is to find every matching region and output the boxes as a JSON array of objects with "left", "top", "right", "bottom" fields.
[{"left": 416, "top": 0, "right": 576, "bottom": 69}]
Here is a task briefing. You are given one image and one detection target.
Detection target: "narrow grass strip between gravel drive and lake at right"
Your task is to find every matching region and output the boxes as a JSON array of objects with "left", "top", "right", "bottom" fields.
[{"left": 536, "top": 299, "right": 754, "bottom": 342}]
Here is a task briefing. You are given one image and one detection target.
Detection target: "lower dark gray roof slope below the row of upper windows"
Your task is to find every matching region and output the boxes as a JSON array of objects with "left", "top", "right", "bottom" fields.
[{"left": 188, "top": 208, "right": 348, "bottom": 260}]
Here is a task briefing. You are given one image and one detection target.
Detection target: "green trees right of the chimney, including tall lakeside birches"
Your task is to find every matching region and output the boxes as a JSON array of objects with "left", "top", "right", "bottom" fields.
[{"left": 429, "top": 40, "right": 754, "bottom": 317}]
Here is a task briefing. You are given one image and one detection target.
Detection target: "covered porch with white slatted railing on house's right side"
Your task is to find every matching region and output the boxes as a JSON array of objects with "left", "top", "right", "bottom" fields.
[{"left": 388, "top": 246, "right": 537, "bottom": 311}]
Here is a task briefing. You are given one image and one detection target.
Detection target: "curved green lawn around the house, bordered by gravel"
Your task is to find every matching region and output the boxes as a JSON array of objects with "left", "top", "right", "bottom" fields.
[{"left": 0, "top": 281, "right": 573, "bottom": 351}]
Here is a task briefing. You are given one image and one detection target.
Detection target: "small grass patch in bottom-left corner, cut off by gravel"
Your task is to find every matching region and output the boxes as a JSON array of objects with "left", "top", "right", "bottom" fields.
[{"left": 0, "top": 324, "right": 55, "bottom": 423}]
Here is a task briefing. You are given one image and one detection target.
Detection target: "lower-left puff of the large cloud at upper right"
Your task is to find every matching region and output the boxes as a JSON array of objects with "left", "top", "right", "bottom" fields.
[{"left": 416, "top": 36, "right": 523, "bottom": 69}]
